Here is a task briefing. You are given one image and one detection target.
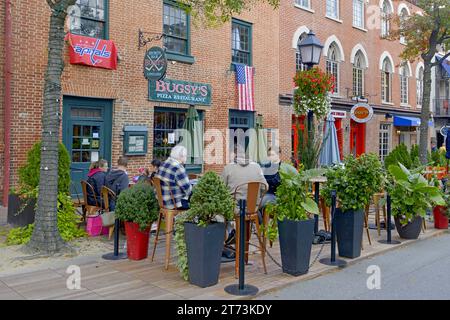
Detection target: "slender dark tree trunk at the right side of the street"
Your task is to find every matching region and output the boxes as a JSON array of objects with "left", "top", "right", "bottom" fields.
[{"left": 419, "top": 59, "right": 432, "bottom": 165}]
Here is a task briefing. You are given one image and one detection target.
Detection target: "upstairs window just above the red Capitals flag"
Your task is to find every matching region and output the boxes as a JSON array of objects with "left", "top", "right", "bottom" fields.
[{"left": 68, "top": 0, "right": 107, "bottom": 39}]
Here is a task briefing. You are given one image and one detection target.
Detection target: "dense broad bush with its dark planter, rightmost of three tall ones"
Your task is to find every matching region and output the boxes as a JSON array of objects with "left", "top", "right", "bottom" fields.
[{"left": 322, "top": 154, "right": 385, "bottom": 258}]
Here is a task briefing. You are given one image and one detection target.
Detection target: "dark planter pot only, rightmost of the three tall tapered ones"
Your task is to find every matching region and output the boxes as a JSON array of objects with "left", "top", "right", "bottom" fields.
[{"left": 335, "top": 208, "right": 364, "bottom": 259}]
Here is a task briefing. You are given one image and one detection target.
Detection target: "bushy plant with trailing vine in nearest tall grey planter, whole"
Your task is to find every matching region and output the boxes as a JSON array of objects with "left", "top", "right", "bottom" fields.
[{"left": 175, "top": 172, "right": 235, "bottom": 288}]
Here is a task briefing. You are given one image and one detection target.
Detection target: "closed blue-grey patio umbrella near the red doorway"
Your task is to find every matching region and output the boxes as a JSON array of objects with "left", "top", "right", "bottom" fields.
[{"left": 319, "top": 113, "right": 341, "bottom": 167}]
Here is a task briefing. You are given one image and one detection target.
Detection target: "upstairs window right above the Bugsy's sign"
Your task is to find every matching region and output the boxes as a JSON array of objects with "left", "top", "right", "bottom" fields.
[{"left": 163, "top": 1, "right": 189, "bottom": 55}]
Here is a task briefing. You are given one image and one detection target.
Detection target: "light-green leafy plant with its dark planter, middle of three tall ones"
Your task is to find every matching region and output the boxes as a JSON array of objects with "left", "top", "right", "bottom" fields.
[{"left": 266, "top": 170, "right": 319, "bottom": 276}]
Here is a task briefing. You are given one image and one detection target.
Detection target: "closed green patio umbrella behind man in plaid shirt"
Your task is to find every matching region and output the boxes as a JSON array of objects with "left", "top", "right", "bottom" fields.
[{"left": 180, "top": 106, "right": 203, "bottom": 164}]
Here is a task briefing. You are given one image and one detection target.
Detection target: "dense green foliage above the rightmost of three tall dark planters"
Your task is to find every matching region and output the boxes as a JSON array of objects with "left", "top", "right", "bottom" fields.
[{"left": 321, "top": 154, "right": 386, "bottom": 212}]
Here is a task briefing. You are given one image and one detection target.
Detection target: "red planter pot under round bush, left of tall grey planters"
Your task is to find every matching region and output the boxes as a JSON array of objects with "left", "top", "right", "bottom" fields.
[{"left": 125, "top": 221, "right": 150, "bottom": 260}]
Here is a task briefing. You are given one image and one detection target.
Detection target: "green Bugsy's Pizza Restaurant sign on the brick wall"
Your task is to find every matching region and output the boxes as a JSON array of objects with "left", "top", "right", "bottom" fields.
[{"left": 148, "top": 79, "right": 212, "bottom": 106}]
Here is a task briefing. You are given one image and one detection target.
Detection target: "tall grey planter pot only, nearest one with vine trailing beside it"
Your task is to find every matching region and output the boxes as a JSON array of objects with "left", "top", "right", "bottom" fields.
[{"left": 184, "top": 222, "right": 225, "bottom": 288}]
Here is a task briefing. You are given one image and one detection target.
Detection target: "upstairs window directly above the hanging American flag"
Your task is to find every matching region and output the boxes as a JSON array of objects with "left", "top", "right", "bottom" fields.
[{"left": 231, "top": 19, "right": 252, "bottom": 65}]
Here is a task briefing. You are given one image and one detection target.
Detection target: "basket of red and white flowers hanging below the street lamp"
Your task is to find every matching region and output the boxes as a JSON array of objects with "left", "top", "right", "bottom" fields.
[{"left": 294, "top": 68, "right": 335, "bottom": 118}]
